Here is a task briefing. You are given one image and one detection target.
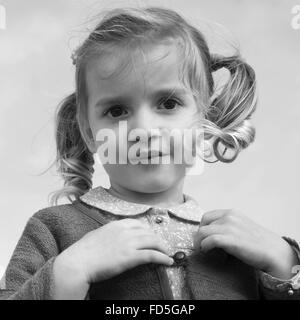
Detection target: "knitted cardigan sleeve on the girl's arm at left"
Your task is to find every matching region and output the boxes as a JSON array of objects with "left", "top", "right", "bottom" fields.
[{"left": 0, "top": 217, "right": 59, "bottom": 300}]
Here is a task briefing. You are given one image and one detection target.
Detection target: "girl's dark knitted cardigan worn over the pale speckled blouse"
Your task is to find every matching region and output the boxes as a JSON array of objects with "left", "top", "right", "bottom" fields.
[{"left": 0, "top": 201, "right": 300, "bottom": 300}]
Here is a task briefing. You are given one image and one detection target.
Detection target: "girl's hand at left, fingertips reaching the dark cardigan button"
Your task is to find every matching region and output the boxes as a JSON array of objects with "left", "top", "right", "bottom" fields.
[{"left": 53, "top": 219, "right": 174, "bottom": 284}]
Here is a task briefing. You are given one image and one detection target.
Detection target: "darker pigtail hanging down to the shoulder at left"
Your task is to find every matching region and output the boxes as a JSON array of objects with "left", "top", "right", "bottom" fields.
[{"left": 51, "top": 93, "right": 94, "bottom": 205}]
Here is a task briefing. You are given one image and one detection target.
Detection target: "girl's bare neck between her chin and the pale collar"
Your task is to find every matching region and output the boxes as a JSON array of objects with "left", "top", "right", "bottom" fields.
[{"left": 107, "top": 180, "right": 184, "bottom": 207}]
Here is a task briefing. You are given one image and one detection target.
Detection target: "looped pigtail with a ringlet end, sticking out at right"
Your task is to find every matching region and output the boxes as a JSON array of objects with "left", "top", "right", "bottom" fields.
[{"left": 206, "top": 55, "right": 257, "bottom": 162}]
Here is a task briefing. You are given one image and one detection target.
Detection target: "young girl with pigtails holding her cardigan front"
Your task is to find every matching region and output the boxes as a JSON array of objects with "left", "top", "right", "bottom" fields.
[{"left": 0, "top": 7, "right": 300, "bottom": 299}]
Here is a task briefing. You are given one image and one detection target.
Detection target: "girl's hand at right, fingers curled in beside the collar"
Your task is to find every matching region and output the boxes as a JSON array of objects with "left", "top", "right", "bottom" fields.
[{"left": 194, "top": 209, "right": 299, "bottom": 279}]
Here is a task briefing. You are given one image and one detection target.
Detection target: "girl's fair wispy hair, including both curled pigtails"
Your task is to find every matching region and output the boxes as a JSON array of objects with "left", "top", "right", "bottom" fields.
[{"left": 51, "top": 7, "right": 257, "bottom": 205}]
